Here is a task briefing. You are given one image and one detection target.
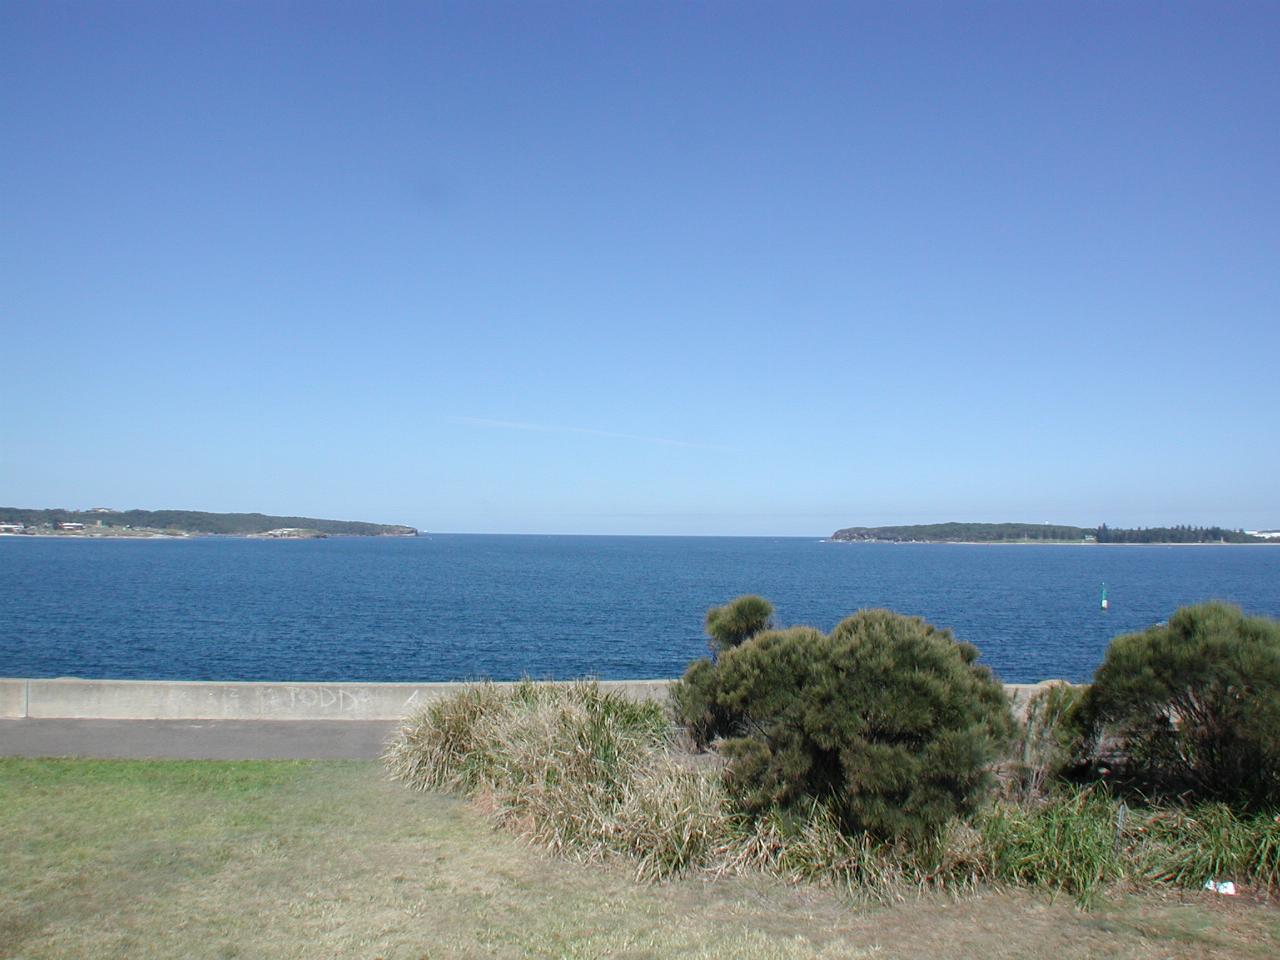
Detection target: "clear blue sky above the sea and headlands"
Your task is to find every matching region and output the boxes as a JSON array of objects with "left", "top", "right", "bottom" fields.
[{"left": 0, "top": 0, "right": 1280, "bottom": 535}]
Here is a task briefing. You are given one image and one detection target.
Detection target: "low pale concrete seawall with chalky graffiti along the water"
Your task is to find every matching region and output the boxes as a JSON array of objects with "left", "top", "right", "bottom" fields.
[{"left": 0, "top": 678, "right": 1051, "bottom": 721}]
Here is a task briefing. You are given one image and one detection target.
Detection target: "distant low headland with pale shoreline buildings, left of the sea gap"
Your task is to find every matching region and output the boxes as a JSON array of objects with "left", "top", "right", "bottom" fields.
[{"left": 0, "top": 507, "right": 417, "bottom": 540}]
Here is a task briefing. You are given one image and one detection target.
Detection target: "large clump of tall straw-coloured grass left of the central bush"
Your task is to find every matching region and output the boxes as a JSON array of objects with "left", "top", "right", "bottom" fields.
[{"left": 384, "top": 682, "right": 724, "bottom": 878}]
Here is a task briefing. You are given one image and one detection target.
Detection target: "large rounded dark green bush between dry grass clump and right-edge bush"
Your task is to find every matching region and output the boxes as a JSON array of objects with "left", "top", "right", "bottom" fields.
[{"left": 719, "top": 611, "right": 1012, "bottom": 845}]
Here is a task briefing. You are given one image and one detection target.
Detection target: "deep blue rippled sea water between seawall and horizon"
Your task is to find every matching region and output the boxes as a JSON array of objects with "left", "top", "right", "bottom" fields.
[{"left": 0, "top": 535, "right": 1280, "bottom": 682}]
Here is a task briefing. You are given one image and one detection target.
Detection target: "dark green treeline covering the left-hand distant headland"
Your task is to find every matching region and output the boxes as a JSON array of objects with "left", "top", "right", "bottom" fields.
[{"left": 0, "top": 507, "right": 417, "bottom": 536}]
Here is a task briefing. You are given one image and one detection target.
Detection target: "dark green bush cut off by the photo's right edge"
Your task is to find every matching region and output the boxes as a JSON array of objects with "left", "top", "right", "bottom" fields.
[{"left": 1085, "top": 602, "right": 1280, "bottom": 805}]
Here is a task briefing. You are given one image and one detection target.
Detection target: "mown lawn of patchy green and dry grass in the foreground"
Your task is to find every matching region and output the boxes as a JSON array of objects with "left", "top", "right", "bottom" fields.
[{"left": 0, "top": 759, "right": 1280, "bottom": 960}]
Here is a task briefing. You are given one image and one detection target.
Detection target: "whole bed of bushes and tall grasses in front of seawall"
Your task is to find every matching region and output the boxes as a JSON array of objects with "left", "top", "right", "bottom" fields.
[{"left": 385, "top": 598, "right": 1280, "bottom": 905}]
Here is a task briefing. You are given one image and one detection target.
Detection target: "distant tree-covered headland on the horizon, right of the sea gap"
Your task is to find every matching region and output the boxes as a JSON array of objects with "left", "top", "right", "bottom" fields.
[{"left": 831, "top": 524, "right": 1274, "bottom": 543}]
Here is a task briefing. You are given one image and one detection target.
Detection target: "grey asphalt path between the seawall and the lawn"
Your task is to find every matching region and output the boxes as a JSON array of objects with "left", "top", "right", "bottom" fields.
[{"left": 0, "top": 719, "right": 397, "bottom": 760}]
